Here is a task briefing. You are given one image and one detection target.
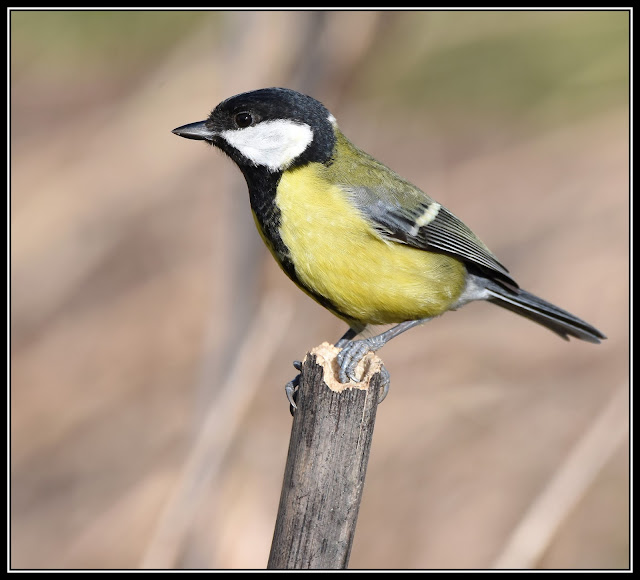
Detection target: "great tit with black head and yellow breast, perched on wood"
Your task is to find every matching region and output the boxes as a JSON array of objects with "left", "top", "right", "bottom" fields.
[{"left": 173, "top": 88, "right": 606, "bottom": 406}]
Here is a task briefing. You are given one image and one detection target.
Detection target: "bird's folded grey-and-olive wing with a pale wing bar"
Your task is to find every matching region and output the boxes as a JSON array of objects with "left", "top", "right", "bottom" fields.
[{"left": 343, "top": 178, "right": 517, "bottom": 287}]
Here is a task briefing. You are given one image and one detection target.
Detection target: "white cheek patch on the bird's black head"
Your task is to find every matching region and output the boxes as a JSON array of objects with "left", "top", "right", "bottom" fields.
[{"left": 220, "top": 119, "right": 313, "bottom": 172}]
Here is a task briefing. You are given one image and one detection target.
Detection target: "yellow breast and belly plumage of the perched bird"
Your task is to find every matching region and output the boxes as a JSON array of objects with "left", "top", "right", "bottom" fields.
[{"left": 276, "top": 163, "right": 466, "bottom": 324}]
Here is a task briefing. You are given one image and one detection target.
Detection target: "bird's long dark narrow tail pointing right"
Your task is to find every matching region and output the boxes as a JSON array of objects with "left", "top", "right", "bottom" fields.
[{"left": 486, "top": 280, "right": 607, "bottom": 343}]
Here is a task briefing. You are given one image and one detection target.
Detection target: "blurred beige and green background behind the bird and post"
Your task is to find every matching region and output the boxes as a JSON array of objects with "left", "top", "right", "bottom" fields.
[{"left": 9, "top": 11, "right": 629, "bottom": 569}]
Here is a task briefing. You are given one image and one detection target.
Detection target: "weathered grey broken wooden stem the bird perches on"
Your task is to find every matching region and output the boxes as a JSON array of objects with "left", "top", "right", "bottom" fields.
[{"left": 267, "top": 346, "right": 381, "bottom": 569}]
